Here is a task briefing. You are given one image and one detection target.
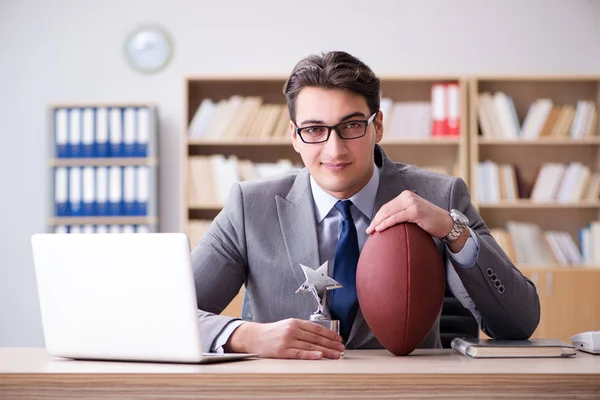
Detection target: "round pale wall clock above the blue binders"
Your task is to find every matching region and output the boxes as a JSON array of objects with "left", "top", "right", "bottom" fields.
[{"left": 125, "top": 27, "right": 173, "bottom": 72}]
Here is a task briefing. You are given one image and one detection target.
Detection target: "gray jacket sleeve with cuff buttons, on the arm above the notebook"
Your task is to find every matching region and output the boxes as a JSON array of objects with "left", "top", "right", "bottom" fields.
[{"left": 449, "top": 178, "right": 540, "bottom": 340}]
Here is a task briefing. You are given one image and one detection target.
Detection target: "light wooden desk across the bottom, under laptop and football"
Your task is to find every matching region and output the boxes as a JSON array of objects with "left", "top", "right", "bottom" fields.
[{"left": 0, "top": 348, "right": 600, "bottom": 400}]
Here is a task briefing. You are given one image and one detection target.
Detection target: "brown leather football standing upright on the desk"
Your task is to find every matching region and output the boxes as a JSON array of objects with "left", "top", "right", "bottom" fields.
[{"left": 356, "top": 223, "right": 445, "bottom": 356}]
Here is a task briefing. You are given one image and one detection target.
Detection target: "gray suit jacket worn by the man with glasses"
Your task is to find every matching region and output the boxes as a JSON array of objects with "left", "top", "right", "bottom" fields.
[{"left": 192, "top": 145, "right": 540, "bottom": 351}]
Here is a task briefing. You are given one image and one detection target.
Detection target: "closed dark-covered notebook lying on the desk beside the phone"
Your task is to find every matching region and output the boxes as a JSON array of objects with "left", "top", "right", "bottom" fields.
[{"left": 450, "top": 338, "right": 577, "bottom": 358}]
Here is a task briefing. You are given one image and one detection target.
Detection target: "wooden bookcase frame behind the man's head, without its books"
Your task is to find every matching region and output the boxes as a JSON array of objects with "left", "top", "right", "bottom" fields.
[{"left": 181, "top": 76, "right": 469, "bottom": 316}]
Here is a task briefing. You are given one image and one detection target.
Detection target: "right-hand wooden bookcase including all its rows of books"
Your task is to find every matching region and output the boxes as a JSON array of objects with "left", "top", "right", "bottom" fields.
[{"left": 469, "top": 76, "right": 600, "bottom": 339}]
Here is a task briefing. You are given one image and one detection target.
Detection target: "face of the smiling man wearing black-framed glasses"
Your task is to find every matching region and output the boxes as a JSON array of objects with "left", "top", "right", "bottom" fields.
[{"left": 290, "top": 87, "right": 383, "bottom": 199}]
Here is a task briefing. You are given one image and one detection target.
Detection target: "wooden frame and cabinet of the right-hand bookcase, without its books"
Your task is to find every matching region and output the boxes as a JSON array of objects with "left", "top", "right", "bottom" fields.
[{"left": 469, "top": 76, "right": 600, "bottom": 341}]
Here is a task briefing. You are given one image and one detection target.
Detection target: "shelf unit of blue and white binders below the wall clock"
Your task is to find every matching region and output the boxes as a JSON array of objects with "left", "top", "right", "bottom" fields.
[{"left": 48, "top": 104, "right": 158, "bottom": 233}]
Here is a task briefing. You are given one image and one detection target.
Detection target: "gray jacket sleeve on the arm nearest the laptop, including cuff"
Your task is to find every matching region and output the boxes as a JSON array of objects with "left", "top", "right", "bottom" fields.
[{"left": 192, "top": 184, "right": 248, "bottom": 352}]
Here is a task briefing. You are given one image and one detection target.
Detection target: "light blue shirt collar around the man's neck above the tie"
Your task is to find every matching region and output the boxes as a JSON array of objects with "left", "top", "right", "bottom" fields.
[{"left": 310, "top": 165, "right": 380, "bottom": 223}]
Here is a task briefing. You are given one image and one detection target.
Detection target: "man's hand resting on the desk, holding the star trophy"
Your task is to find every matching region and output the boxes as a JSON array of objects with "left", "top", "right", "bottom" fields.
[{"left": 225, "top": 319, "right": 344, "bottom": 360}]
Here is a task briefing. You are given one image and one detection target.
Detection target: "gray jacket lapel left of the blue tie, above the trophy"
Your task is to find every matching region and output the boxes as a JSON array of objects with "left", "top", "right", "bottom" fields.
[{"left": 275, "top": 169, "right": 319, "bottom": 288}]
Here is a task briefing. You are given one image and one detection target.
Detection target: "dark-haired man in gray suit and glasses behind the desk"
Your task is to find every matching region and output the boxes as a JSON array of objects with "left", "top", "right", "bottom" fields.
[{"left": 192, "top": 52, "right": 540, "bottom": 359}]
